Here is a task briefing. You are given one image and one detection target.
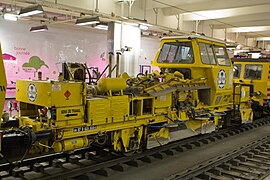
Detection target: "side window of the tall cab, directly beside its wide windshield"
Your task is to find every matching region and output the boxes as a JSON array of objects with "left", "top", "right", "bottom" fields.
[{"left": 199, "top": 43, "right": 216, "bottom": 64}]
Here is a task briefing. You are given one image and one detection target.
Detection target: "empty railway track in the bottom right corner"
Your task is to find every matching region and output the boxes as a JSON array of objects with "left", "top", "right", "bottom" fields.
[{"left": 166, "top": 135, "right": 270, "bottom": 180}]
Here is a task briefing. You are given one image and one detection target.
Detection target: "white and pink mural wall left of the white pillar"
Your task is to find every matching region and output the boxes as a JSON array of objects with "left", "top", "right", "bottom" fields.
[{"left": 0, "top": 20, "right": 107, "bottom": 97}]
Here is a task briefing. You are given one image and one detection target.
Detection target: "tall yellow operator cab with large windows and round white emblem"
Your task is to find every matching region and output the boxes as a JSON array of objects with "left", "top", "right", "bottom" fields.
[{"left": 152, "top": 35, "right": 233, "bottom": 105}]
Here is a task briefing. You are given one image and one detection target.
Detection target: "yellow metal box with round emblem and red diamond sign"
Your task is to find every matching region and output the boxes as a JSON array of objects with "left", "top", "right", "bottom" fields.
[{"left": 16, "top": 80, "right": 82, "bottom": 107}]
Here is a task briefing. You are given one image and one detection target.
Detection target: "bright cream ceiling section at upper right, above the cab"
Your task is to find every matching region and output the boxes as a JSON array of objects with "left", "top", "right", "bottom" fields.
[{"left": 151, "top": 0, "right": 270, "bottom": 36}]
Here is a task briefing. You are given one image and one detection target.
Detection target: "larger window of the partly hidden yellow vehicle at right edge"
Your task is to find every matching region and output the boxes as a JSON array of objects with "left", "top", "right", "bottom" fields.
[{"left": 244, "top": 64, "right": 262, "bottom": 80}]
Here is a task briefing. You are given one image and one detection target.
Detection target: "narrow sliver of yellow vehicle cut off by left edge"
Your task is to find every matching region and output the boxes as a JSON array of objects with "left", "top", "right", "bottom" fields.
[{"left": 0, "top": 44, "right": 7, "bottom": 115}]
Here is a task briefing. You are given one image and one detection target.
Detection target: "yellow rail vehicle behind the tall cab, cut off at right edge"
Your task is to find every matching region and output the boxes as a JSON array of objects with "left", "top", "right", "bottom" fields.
[{"left": 233, "top": 59, "right": 270, "bottom": 117}]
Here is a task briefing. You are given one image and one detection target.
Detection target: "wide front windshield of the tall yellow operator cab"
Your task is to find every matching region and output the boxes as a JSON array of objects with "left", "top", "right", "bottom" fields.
[{"left": 158, "top": 42, "right": 194, "bottom": 64}]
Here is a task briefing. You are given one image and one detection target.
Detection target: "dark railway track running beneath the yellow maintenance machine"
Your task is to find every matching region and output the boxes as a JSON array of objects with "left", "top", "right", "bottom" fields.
[{"left": 0, "top": 118, "right": 270, "bottom": 179}]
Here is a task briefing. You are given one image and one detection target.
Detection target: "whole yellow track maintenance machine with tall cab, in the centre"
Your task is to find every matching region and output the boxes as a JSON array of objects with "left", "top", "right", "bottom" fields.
[{"left": 2, "top": 35, "right": 253, "bottom": 158}]
